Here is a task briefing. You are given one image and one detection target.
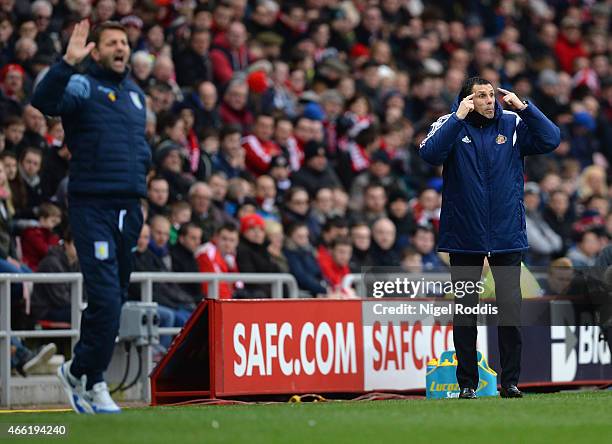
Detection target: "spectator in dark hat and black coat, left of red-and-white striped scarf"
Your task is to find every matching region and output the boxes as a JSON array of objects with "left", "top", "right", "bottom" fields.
[{"left": 291, "top": 140, "right": 340, "bottom": 197}]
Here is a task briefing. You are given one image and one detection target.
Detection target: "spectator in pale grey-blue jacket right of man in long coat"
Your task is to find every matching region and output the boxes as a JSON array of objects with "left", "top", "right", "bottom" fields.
[{"left": 524, "top": 182, "right": 563, "bottom": 266}]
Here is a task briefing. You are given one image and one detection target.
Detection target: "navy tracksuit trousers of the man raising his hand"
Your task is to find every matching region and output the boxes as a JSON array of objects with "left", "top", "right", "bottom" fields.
[{"left": 68, "top": 197, "right": 142, "bottom": 389}]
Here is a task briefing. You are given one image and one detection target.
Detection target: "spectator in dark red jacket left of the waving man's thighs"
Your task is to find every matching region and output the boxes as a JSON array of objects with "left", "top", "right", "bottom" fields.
[{"left": 21, "top": 203, "right": 62, "bottom": 271}]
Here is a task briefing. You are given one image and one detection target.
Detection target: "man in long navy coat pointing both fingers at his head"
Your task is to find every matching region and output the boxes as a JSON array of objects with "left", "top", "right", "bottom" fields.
[{"left": 419, "top": 77, "right": 560, "bottom": 398}]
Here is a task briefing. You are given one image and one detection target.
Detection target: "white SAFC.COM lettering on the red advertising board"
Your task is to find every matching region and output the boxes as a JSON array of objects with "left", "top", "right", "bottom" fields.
[{"left": 233, "top": 322, "right": 357, "bottom": 377}]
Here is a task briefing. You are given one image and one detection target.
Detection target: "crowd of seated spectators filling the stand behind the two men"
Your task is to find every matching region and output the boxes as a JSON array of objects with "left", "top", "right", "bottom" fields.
[{"left": 0, "top": 0, "right": 612, "bottom": 332}]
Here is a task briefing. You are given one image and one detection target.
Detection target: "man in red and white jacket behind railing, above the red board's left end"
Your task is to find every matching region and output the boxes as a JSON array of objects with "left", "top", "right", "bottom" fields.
[{"left": 195, "top": 223, "right": 242, "bottom": 299}]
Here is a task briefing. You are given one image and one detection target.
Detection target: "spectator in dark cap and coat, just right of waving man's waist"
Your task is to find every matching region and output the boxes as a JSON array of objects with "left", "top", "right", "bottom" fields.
[{"left": 155, "top": 139, "right": 194, "bottom": 203}]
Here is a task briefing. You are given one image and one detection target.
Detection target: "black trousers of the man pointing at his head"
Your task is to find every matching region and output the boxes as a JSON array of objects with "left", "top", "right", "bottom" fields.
[{"left": 450, "top": 252, "right": 522, "bottom": 389}]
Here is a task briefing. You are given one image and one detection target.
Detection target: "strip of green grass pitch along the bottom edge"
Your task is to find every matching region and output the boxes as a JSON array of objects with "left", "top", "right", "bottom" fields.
[{"left": 0, "top": 390, "right": 612, "bottom": 444}]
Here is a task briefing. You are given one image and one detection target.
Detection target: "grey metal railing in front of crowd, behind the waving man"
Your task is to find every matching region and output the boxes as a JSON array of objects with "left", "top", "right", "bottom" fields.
[{"left": 0, "top": 272, "right": 299, "bottom": 407}]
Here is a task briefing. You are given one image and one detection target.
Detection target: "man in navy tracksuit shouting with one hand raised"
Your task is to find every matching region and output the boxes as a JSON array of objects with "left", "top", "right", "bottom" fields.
[{"left": 32, "top": 21, "right": 151, "bottom": 413}]
